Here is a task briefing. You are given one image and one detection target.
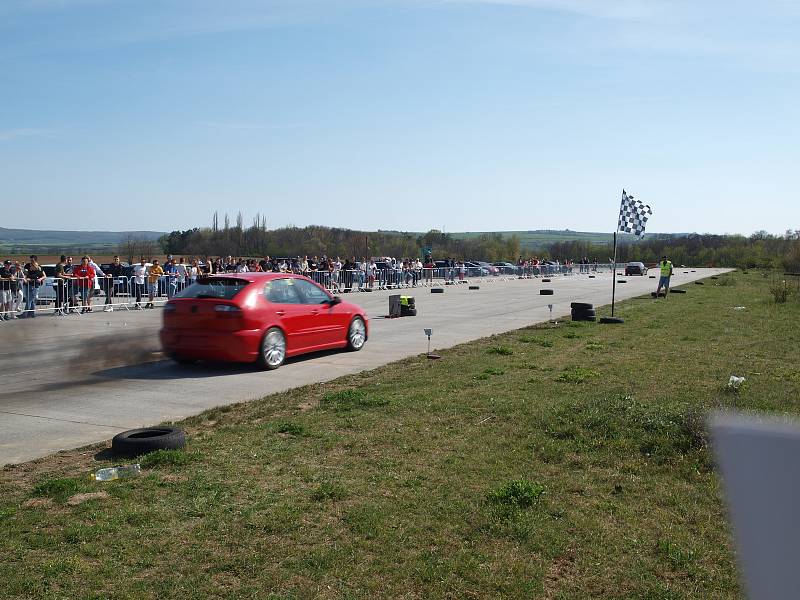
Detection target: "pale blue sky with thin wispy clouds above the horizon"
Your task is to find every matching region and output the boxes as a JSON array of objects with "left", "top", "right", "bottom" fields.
[{"left": 0, "top": 0, "right": 800, "bottom": 234}]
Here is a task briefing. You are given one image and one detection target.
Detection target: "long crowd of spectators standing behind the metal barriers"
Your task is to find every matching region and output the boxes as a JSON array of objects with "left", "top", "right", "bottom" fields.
[{"left": 0, "top": 254, "right": 598, "bottom": 320}]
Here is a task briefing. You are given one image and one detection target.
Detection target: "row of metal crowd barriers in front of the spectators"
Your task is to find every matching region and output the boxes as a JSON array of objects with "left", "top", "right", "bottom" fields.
[{"left": 0, "top": 263, "right": 625, "bottom": 317}]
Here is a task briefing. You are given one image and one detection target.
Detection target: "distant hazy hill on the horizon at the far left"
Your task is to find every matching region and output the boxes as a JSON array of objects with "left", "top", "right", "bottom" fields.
[{"left": 0, "top": 227, "right": 164, "bottom": 254}]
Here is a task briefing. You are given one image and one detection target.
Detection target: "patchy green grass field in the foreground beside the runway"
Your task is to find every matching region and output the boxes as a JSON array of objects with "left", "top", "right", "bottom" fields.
[{"left": 0, "top": 272, "right": 800, "bottom": 599}]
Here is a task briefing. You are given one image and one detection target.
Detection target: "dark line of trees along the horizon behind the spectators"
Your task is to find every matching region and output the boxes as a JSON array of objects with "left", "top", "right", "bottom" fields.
[{"left": 120, "top": 213, "right": 800, "bottom": 272}]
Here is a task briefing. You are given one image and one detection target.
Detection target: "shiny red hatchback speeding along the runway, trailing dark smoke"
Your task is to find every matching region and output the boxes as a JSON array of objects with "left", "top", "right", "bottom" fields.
[{"left": 160, "top": 273, "right": 368, "bottom": 369}]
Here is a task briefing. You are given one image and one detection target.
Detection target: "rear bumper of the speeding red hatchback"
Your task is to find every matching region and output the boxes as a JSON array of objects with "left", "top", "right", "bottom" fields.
[{"left": 159, "top": 329, "right": 261, "bottom": 362}]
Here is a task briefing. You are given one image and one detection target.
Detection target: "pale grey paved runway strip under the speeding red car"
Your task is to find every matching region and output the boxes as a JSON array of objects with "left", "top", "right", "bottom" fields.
[{"left": 0, "top": 269, "right": 728, "bottom": 465}]
